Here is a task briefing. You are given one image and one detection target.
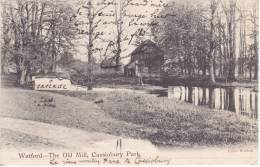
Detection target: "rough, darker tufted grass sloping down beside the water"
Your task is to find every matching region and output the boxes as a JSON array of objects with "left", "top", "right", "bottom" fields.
[{"left": 53, "top": 88, "right": 257, "bottom": 147}]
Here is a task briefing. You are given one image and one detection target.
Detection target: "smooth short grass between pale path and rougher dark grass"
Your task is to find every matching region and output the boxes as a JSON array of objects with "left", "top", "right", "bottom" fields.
[{"left": 0, "top": 88, "right": 156, "bottom": 144}]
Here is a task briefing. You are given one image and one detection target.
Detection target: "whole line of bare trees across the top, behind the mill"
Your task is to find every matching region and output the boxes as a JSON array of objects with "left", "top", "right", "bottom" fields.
[{"left": 1, "top": 0, "right": 258, "bottom": 89}]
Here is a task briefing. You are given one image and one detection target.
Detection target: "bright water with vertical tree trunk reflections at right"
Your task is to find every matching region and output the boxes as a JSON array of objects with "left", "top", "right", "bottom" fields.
[{"left": 168, "top": 86, "right": 257, "bottom": 119}]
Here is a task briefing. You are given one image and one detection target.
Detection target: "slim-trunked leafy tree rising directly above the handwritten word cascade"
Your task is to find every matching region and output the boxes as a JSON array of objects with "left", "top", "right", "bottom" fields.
[{"left": 46, "top": 2, "right": 76, "bottom": 72}]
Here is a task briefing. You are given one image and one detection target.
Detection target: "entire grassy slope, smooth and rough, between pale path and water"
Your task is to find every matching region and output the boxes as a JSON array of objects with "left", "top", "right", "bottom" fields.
[{"left": 0, "top": 89, "right": 257, "bottom": 147}]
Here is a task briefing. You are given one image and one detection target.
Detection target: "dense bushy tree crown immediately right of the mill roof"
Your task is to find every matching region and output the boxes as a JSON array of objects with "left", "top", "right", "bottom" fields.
[{"left": 152, "top": 3, "right": 209, "bottom": 75}]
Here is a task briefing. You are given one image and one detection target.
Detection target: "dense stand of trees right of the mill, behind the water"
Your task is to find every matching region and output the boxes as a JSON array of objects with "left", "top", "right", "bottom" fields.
[{"left": 152, "top": 0, "right": 258, "bottom": 83}]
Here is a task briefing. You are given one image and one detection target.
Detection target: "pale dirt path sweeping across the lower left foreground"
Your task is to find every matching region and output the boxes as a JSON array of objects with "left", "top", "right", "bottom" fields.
[{"left": 0, "top": 117, "right": 158, "bottom": 165}]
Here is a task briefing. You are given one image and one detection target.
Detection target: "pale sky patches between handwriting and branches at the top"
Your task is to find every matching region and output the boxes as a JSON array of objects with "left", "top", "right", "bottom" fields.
[{"left": 67, "top": 0, "right": 258, "bottom": 62}]
